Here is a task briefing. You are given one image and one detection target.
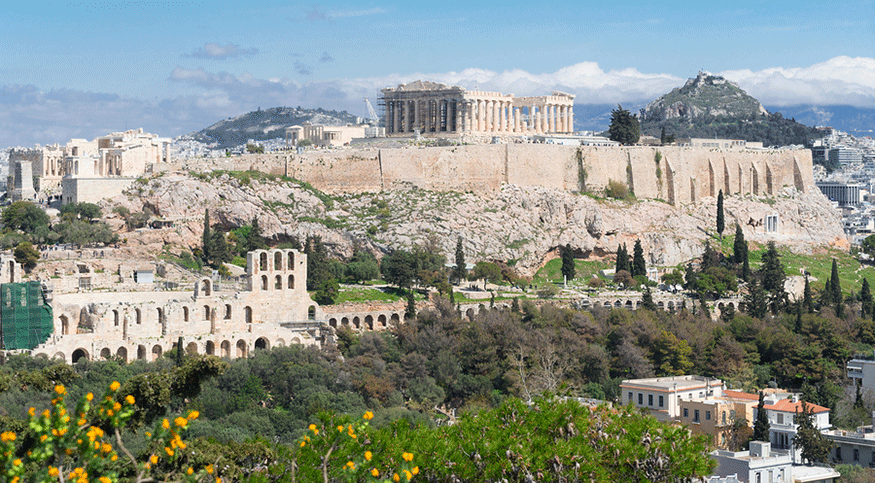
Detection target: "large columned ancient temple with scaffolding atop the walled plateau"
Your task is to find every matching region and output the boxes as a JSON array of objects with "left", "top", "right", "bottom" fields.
[{"left": 381, "top": 81, "right": 574, "bottom": 136}]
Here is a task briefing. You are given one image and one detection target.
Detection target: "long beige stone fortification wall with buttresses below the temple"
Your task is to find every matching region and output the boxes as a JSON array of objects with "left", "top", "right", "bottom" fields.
[{"left": 179, "top": 144, "right": 814, "bottom": 204}]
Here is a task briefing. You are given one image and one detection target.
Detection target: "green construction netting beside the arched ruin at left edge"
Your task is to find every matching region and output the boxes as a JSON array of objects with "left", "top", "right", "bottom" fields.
[{"left": 0, "top": 282, "right": 54, "bottom": 350}]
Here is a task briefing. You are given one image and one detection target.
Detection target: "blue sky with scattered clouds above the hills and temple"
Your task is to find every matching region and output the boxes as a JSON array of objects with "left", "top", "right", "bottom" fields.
[{"left": 0, "top": 0, "right": 875, "bottom": 148}]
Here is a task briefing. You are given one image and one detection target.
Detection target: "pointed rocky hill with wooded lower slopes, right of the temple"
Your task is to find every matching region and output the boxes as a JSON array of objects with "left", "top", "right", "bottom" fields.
[{"left": 639, "top": 72, "right": 820, "bottom": 146}]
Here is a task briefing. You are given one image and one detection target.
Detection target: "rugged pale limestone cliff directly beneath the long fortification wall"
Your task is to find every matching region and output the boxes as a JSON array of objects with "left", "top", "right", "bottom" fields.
[{"left": 105, "top": 173, "right": 847, "bottom": 275}]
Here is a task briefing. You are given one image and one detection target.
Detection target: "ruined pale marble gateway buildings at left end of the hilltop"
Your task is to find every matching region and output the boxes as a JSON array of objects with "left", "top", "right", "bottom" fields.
[{"left": 7, "top": 128, "right": 170, "bottom": 203}]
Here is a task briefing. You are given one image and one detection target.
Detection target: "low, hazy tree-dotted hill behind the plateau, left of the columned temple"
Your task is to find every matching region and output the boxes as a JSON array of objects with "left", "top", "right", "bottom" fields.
[{"left": 182, "top": 107, "right": 359, "bottom": 149}]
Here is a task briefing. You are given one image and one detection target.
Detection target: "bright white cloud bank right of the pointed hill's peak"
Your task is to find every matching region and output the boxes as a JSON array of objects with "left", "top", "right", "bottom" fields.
[{"left": 720, "top": 56, "right": 875, "bottom": 107}]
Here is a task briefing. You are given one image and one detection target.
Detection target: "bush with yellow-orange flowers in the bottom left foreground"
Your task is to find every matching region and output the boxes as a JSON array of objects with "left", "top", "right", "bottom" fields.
[{"left": 0, "top": 382, "right": 221, "bottom": 483}]
